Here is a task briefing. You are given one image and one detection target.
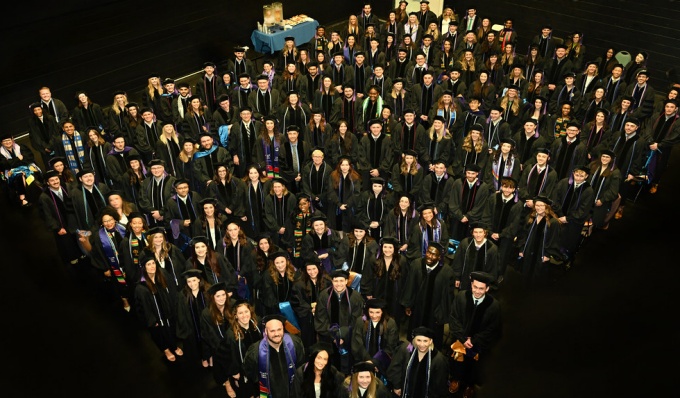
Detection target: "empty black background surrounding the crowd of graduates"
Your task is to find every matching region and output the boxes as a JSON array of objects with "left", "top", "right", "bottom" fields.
[{"left": 0, "top": 0, "right": 680, "bottom": 398}]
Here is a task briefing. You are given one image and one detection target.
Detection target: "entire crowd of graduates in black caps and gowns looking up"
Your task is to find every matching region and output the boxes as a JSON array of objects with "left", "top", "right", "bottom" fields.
[{"left": 0, "top": 1, "right": 680, "bottom": 398}]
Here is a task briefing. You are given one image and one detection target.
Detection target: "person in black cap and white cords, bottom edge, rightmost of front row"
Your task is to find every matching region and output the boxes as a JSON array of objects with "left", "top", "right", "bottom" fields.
[{"left": 388, "top": 326, "right": 449, "bottom": 398}]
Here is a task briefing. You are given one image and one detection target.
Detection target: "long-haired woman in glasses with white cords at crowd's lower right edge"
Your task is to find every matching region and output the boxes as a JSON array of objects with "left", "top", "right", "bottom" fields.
[{"left": 517, "top": 196, "right": 561, "bottom": 289}]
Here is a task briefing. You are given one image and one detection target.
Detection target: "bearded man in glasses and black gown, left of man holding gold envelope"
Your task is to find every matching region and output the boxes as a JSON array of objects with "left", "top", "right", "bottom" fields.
[{"left": 404, "top": 242, "right": 455, "bottom": 347}]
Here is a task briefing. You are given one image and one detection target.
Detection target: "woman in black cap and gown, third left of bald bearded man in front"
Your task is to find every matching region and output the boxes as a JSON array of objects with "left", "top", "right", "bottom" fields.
[{"left": 177, "top": 268, "right": 210, "bottom": 368}]
